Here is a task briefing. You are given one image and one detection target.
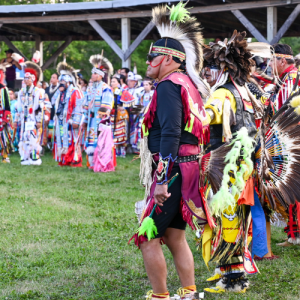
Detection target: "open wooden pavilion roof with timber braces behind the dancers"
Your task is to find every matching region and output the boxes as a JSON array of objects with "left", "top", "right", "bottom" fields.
[{"left": 0, "top": 0, "right": 300, "bottom": 70}]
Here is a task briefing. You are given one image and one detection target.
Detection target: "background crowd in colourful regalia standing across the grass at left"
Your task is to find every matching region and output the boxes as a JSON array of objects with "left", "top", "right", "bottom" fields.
[{"left": 1, "top": 49, "right": 153, "bottom": 172}]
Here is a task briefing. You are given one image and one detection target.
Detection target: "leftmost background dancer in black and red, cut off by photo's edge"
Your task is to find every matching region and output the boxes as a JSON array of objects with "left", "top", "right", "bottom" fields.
[{"left": 0, "top": 63, "right": 14, "bottom": 163}]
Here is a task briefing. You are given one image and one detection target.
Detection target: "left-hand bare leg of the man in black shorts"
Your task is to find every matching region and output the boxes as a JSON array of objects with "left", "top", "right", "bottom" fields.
[{"left": 141, "top": 239, "right": 168, "bottom": 294}]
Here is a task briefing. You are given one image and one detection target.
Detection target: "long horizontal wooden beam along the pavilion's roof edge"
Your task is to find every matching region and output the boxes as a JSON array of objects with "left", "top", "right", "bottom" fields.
[{"left": 0, "top": 0, "right": 300, "bottom": 24}]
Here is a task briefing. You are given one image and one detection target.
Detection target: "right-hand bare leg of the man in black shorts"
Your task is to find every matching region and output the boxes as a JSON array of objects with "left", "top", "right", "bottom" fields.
[{"left": 164, "top": 228, "right": 195, "bottom": 287}]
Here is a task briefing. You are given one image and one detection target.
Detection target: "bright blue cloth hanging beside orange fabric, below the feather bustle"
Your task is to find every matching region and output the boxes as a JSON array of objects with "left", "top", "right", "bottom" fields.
[{"left": 251, "top": 190, "right": 269, "bottom": 257}]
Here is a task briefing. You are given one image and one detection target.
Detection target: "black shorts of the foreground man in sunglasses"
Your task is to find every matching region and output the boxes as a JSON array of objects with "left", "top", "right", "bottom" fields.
[{"left": 153, "top": 166, "right": 186, "bottom": 238}]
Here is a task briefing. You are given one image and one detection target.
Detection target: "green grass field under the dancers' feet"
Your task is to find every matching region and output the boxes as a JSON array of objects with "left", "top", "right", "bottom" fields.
[{"left": 0, "top": 153, "right": 300, "bottom": 300}]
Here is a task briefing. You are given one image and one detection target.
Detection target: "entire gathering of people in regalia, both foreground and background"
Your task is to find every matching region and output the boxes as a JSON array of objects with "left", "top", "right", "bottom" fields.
[{"left": 0, "top": 2, "right": 300, "bottom": 300}]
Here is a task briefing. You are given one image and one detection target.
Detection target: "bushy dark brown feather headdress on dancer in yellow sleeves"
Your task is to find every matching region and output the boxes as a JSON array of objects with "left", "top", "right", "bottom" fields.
[{"left": 203, "top": 30, "right": 254, "bottom": 86}]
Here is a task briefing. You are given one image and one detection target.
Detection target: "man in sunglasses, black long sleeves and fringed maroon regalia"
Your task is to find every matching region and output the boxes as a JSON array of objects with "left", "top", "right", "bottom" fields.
[{"left": 132, "top": 3, "right": 211, "bottom": 300}]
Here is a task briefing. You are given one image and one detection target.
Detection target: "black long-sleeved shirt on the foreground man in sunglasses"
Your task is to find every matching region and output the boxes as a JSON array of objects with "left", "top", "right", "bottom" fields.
[{"left": 148, "top": 80, "right": 198, "bottom": 158}]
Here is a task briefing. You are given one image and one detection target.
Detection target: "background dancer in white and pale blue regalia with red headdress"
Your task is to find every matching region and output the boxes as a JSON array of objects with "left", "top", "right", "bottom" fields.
[{"left": 14, "top": 61, "right": 45, "bottom": 165}]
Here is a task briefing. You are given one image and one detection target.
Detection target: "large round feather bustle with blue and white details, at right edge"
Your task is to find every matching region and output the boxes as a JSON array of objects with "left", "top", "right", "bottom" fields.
[{"left": 255, "top": 93, "right": 300, "bottom": 209}]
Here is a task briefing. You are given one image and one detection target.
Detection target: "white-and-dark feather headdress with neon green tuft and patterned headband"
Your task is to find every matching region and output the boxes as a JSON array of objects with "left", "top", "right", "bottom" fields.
[{"left": 150, "top": 2, "right": 210, "bottom": 97}]
